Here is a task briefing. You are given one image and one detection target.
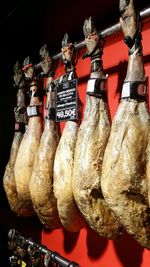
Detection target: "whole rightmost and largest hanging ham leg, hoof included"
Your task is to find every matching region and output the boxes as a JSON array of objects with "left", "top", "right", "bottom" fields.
[{"left": 101, "top": 0, "right": 150, "bottom": 249}]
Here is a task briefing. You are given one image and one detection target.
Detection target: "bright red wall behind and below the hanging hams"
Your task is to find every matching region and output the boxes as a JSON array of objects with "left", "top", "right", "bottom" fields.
[{"left": 42, "top": 21, "right": 150, "bottom": 267}]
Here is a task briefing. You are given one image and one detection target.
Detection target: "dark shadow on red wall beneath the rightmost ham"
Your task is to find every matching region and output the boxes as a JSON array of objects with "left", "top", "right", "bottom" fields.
[{"left": 113, "top": 234, "right": 144, "bottom": 267}]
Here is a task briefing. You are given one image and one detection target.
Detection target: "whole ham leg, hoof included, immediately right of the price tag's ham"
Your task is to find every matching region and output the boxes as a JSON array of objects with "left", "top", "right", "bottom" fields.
[{"left": 73, "top": 17, "right": 122, "bottom": 239}]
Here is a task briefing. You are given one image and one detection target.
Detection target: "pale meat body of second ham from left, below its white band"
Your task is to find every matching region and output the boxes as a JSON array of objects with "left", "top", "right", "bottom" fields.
[{"left": 15, "top": 117, "right": 42, "bottom": 211}]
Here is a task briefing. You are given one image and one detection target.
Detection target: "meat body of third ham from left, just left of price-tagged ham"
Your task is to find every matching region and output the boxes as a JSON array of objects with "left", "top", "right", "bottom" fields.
[{"left": 29, "top": 120, "right": 61, "bottom": 229}]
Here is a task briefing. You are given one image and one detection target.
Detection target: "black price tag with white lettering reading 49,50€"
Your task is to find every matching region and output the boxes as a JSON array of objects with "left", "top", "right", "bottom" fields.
[{"left": 56, "top": 79, "right": 78, "bottom": 122}]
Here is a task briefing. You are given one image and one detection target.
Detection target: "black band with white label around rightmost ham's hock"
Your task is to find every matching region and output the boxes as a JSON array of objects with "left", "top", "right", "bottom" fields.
[{"left": 121, "top": 81, "right": 147, "bottom": 101}]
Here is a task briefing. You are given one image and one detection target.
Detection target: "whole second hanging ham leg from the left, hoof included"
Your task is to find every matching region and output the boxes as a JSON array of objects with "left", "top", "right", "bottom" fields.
[{"left": 15, "top": 57, "right": 43, "bottom": 214}]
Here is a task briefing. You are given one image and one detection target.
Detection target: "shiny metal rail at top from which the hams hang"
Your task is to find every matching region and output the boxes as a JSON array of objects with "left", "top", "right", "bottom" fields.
[{"left": 53, "top": 7, "right": 150, "bottom": 60}]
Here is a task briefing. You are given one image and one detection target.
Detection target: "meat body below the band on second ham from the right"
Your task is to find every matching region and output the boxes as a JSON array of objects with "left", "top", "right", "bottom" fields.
[{"left": 73, "top": 95, "right": 122, "bottom": 239}]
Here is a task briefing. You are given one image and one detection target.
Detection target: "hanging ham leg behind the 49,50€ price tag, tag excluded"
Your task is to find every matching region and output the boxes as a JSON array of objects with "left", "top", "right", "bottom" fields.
[{"left": 54, "top": 35, "right": 85, "bottom": 232}]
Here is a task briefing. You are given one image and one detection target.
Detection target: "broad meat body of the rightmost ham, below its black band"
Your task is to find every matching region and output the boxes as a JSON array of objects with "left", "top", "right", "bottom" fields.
[{"left": 101, "top": 100, "right": 150, "bottom": 248}]
